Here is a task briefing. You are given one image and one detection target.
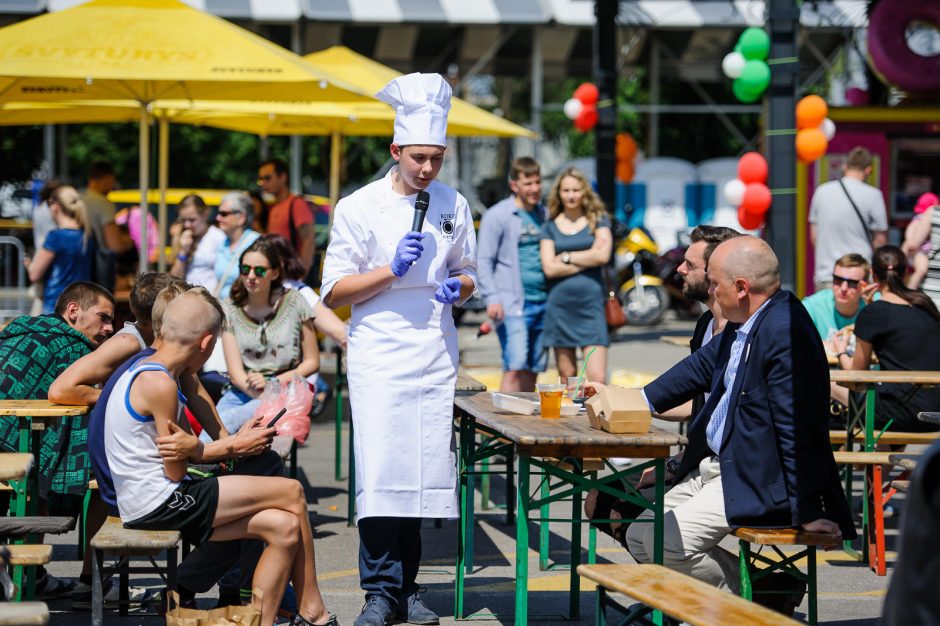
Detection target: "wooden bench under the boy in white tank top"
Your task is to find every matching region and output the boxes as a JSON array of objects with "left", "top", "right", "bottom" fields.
[{"left": 90, "top": 517, "right": 180, "bottom": 626}]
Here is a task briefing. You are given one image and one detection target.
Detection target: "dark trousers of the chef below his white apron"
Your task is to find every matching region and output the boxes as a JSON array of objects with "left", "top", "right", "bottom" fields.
[{"left": 358, "top": 517, "right": 421, "bottom": 609}]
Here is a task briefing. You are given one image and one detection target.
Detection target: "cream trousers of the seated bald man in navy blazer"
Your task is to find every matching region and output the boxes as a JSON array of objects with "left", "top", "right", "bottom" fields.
[{"left": 626, "top": 456, "right": 738, "bottom": 593}]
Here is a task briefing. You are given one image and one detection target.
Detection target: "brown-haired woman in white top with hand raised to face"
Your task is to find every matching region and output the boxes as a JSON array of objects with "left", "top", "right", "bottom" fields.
[{"left": 170, "top": 193, "right": 225, "bottom": 292}]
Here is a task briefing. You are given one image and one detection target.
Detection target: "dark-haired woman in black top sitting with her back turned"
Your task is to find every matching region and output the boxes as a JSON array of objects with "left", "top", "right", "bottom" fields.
[{"left": 833, "top": 246, "right": 940, "bottom": 431}]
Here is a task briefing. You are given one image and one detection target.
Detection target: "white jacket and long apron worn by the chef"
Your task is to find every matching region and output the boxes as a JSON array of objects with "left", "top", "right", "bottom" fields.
[{"left": 321, "top": 172, "right": 476, "bottom": 518}]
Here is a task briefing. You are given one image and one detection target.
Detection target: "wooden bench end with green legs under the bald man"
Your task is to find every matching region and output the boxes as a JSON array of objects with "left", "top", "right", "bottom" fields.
[{"left": 731, "top": 528, "right": 841, "bottom": 624}]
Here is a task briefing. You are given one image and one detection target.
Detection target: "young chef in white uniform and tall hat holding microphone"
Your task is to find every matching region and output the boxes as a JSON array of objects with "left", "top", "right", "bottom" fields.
[{"left": 321, "top": 74, "right": 476, "bottom": 626}]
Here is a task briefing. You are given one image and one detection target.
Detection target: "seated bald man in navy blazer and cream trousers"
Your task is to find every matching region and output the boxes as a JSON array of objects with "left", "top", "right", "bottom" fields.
[{"left": 626, "top": 237, "right": 855, "bottom": 589}]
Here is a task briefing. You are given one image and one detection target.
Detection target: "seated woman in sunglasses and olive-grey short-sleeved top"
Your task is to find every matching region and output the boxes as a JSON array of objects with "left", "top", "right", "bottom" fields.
[{"left": 217, "top": 239, "right": 320, "bottom": 433}]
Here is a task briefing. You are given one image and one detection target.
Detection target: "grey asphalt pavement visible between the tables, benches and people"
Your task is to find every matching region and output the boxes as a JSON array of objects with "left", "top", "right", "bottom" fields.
[{"left": 38, "top": 314, "right": 888, "bottom": 626}]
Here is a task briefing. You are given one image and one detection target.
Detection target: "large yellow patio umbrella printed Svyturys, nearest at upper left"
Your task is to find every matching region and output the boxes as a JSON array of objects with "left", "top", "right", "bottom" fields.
[{"left": 0, "top": 0, "right": 374, "bottom": 269}]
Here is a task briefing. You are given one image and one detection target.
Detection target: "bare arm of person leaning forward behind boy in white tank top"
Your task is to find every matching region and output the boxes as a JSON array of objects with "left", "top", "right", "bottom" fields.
[{"left": 49, "top": 334, "right": 140, "bottom": 406}]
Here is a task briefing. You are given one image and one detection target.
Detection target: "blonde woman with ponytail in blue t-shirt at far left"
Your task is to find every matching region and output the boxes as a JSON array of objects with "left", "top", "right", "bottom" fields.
[{"left": 26, "top": 185, "right": 96, "bottom": 313}]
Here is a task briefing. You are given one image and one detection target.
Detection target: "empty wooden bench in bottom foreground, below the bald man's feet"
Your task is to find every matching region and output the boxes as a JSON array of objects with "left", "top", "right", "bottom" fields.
[{"left": 578, "top": 564, "right": 799, "bottom": 626}]
